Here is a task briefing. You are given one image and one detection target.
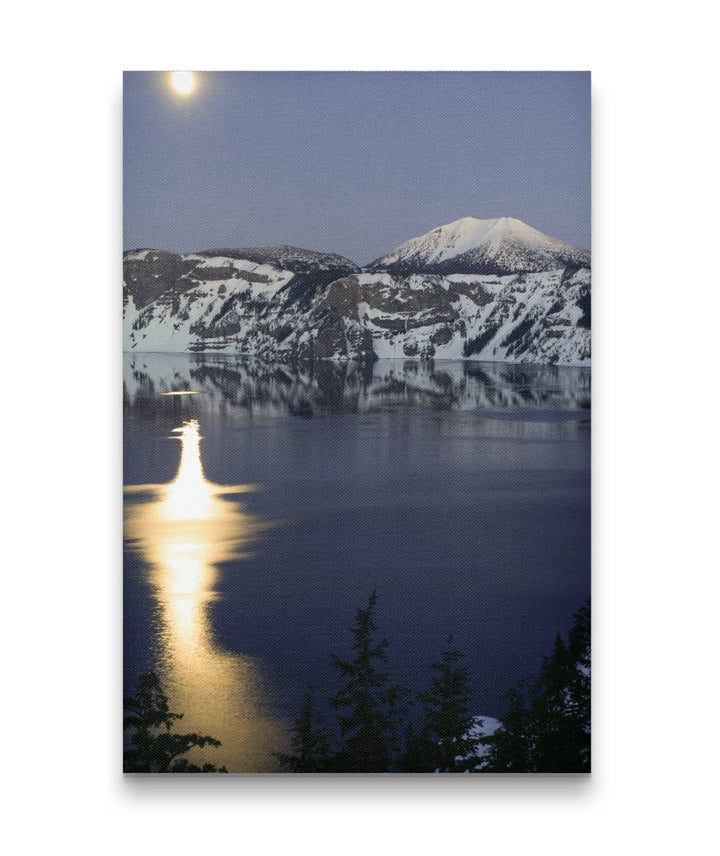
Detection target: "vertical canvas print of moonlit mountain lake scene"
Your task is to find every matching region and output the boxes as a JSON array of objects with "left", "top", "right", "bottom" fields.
[{"left": 123, "top": 71, "right": 591, "bottom": 775}]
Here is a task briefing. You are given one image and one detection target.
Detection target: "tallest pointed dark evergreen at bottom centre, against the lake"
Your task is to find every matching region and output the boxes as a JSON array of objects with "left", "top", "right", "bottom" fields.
[{"left": 332, "top": 591, "right": 406, "bottom": 773}]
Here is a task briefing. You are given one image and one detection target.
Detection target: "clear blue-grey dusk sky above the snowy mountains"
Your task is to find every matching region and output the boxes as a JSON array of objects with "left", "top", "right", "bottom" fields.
[{"left": 123, "top": 71, "right": 590, "bottom": 265}]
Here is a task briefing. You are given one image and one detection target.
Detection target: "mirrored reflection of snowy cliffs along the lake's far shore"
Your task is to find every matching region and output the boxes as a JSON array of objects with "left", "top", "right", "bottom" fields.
[{"left": 125, "top": 354, "right": 590, "bottom": 418}]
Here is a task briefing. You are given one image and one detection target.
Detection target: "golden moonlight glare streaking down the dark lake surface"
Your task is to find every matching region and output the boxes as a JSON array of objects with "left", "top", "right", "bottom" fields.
[{"left": 125, "top": 420, "right": 286, "bottom": 772}]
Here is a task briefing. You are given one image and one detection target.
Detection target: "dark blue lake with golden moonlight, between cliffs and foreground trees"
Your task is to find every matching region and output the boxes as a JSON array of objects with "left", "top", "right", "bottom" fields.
[{"left": 124, "top": 354, "right": 590, "bottom": 771}]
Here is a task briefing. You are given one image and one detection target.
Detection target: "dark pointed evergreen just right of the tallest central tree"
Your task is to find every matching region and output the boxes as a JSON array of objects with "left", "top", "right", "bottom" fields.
[{"left": 418, "top": 636, "right": 480, "bottom": 773}]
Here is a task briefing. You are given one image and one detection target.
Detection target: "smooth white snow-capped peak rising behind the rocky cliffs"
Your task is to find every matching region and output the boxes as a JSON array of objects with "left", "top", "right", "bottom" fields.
[{"left": 368, "top": 217, "right": 590, "bottom": 274}]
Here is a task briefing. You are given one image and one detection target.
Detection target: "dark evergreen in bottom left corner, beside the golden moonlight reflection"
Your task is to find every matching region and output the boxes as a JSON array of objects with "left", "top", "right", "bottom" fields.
[{"left": 123, "top": 672, "right": 227, "bottom": 773}]
